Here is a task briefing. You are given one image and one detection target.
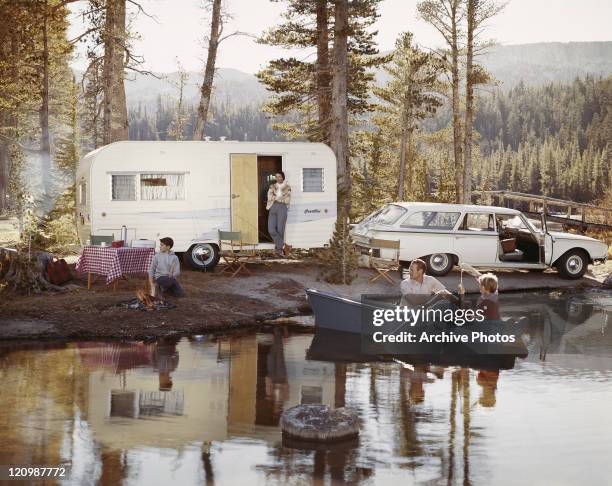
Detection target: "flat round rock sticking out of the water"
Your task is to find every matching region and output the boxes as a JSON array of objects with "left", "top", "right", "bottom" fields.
[{"left": 281, "top": 405, "right": 359, "bottom": 442}]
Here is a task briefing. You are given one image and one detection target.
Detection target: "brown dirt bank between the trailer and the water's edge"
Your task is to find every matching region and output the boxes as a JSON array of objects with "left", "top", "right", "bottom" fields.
[{"left": 0, "top": 258, "right": 612, "bottom": 339}]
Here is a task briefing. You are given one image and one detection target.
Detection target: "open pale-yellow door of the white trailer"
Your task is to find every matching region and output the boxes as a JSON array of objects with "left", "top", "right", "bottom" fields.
[{"left": 230, "top": 154, "right": 259, "bottom": 243}]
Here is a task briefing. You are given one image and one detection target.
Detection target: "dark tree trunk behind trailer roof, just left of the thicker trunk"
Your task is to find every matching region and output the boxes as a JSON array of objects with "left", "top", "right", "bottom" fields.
[{"left": 316, "top": 0, "right": 331, "bottom": 143}]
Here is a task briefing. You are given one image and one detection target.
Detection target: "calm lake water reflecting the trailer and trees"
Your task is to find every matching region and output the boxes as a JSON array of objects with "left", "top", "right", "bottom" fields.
[{"left": 0, "top": 293, "right": 612, "bottom": 486}]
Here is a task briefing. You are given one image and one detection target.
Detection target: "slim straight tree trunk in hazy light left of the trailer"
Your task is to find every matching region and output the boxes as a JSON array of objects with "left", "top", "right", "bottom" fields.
[{"left": 38, "top": 0, "right": 51, "bottom": 196}]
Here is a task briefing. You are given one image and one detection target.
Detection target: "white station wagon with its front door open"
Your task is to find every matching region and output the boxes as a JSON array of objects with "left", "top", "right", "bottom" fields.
[{"left": 351, "top": 202, "right": 608, "bottom": 279}]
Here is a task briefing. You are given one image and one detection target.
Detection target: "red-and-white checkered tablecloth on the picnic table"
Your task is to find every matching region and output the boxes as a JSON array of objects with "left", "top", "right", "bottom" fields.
[{"left": 76, "top": 246, "right": 155, "bottom": 285}]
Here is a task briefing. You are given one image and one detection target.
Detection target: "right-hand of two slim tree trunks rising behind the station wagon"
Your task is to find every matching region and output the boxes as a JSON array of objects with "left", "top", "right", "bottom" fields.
[{"left": 463, "top": 0, "right": 475, "bottom": 204}]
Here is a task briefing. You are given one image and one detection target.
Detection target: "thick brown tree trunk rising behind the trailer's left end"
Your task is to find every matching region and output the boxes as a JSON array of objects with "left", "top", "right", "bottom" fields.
[{"left": 102, "top": 0, "right": 128, "bottom": 145}]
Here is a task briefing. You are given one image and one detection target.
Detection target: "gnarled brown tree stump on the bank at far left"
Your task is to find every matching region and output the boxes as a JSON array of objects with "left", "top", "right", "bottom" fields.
[{"left": 0, "top": 248, "right": 66, "bottom": 294}]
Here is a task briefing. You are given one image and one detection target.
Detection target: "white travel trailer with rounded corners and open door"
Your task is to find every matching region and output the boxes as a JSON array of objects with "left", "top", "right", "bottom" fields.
[{"left": 77, "top": 141, "right": 336, "bottom": 269}]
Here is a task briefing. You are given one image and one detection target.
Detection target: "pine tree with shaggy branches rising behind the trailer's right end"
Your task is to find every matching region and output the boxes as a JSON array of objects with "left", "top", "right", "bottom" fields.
[{"left": 257, "top": 0, "right": 388, "bottom": 142}]
